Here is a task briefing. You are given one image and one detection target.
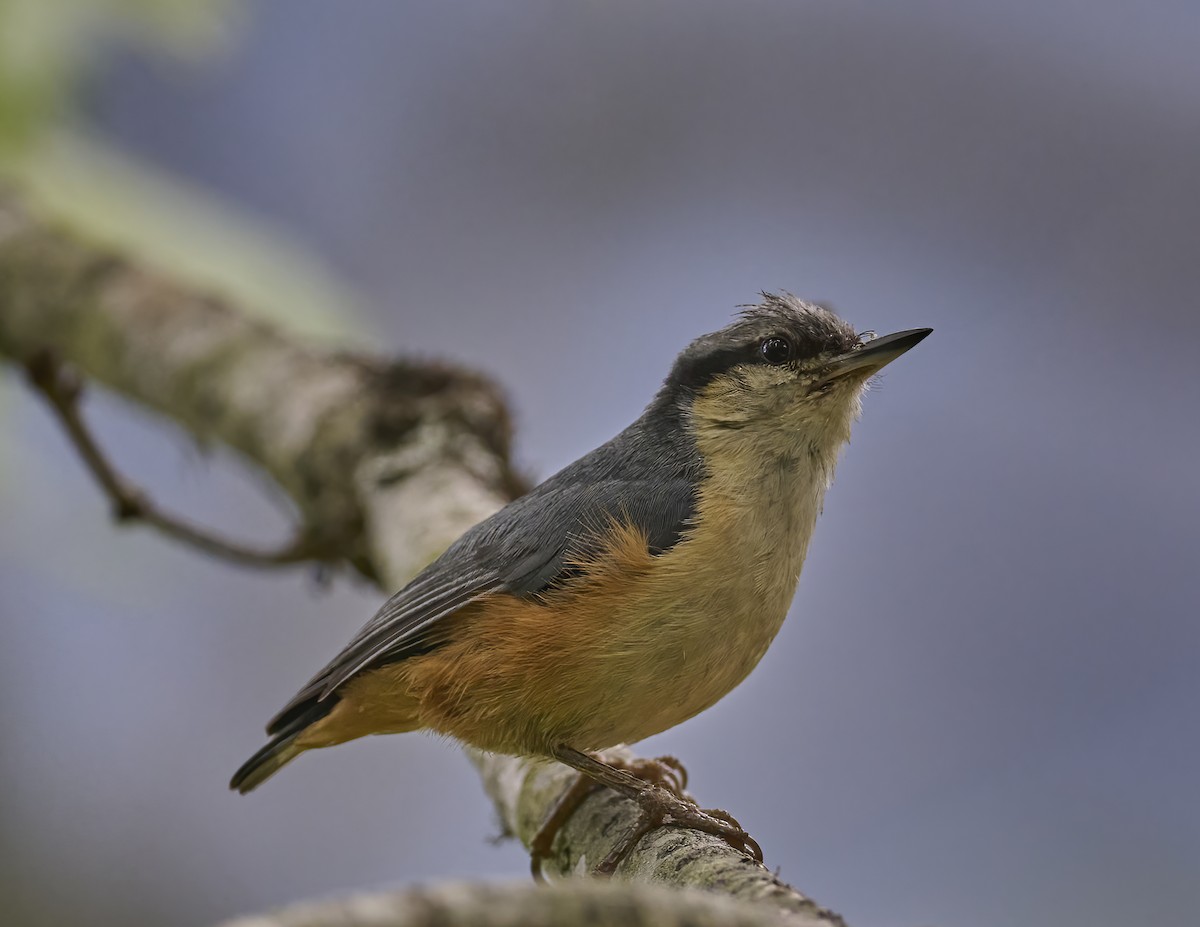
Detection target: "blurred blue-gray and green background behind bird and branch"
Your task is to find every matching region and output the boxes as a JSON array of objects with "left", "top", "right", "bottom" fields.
[{"left": 0, "top": 0, "right": 1200, "bottom": 927}]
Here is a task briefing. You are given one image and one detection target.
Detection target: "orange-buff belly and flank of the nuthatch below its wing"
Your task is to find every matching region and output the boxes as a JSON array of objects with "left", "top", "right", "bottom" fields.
[{"left": 300, "top": 518, "right": 798, "bottom": 755}]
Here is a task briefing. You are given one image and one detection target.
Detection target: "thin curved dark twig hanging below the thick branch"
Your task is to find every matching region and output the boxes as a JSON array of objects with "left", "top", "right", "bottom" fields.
[{"left": 25, "top": 351, "right": 338, "bottom": 567}]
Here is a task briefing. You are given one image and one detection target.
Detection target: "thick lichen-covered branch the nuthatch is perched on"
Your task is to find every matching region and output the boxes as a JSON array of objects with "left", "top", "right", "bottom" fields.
[{"left": 0, "top": 189, "right": 841, "bottom": 927}]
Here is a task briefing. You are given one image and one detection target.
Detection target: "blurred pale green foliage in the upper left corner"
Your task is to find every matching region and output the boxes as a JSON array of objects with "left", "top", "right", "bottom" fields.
[{"left": 0, "top": 0, "right": 362, "bottom": 341}]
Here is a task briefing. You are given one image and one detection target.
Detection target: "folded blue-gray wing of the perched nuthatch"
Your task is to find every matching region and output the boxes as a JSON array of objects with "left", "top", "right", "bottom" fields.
[{"left": 268, "top": 479, "right": 695, "bottom": 734}]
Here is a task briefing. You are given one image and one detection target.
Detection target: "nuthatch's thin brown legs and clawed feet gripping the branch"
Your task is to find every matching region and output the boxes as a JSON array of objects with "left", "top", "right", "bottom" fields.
[{"left": 530, "top": 746, "right": 762, "bottom": 877}]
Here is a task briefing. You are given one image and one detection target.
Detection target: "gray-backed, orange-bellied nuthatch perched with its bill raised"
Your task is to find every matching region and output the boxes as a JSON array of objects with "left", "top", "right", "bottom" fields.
[{"left": 230, "top": 294, "right": 931, "bottom": 868}]
